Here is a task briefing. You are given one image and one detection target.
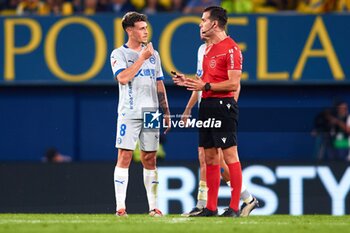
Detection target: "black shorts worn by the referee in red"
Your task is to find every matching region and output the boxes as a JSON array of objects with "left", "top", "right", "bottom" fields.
[{"left": 198, "top": 97, "right": 238, "bottom": 149}]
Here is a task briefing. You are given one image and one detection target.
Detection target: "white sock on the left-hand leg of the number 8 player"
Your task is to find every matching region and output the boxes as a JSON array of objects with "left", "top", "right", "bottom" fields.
[{"left": 114, "top": 166, "right": 129, "bottom": 211}]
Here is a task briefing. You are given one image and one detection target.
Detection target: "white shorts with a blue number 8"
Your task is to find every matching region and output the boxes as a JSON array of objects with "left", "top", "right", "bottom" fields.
[{"left": 115, "top": 118, "right": 159, "bottom": 151}]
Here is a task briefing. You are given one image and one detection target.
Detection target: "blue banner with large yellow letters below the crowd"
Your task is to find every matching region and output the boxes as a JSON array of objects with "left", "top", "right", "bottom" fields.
[{"left": 0, "top": 14, "right": 350, "bottom": 83}]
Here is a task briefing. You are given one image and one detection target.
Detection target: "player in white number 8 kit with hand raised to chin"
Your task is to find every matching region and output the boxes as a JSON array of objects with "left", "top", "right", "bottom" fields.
[{"left": 111, "top": 12, "right": 170, "bottom": 217}]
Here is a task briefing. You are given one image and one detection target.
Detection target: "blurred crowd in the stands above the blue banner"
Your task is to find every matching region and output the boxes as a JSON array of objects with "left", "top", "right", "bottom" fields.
[{"left": 0, "top": 0, "right": 350, "bottom": 15}]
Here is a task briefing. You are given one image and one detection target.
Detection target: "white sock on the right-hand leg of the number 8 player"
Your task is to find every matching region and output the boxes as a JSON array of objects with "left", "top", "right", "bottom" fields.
[{"left": 143, "top": 168, "right": 159, "bottom": 210}]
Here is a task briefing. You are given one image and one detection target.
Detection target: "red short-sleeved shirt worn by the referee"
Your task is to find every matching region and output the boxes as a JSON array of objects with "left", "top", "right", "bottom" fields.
[{"left": 202, "top": 37, "right": 243, "bottom": 98}]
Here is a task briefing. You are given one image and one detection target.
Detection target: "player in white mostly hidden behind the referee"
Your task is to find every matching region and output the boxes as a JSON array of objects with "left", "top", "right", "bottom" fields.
[{"left": 175, "top": 41, "right": 259, "bottom": 217}]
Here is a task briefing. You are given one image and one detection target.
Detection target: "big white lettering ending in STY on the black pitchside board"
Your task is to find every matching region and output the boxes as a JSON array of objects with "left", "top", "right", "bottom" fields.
[{"left": 159, "top": 165, "right": 350, "bottom": 215}]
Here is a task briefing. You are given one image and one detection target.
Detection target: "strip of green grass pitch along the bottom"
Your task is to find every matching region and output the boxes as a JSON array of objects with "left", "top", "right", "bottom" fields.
[{"left": 0, "top": 214, "right": 350, "bottom": 233}]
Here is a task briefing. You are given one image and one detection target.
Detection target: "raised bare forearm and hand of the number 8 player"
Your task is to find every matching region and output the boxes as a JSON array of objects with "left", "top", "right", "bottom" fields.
[{"left": 115, "top": 42, "right": 154, "bottom": 85}]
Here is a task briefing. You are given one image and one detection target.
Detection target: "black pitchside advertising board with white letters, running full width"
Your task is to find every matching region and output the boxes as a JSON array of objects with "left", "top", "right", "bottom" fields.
[{"left": 0, "top": 161, "right": 350, "bottom": 215}]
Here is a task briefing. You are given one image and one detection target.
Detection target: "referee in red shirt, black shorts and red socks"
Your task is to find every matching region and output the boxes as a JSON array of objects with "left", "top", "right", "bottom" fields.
[{"left": 177, "top": 6, "right": 242, "bottom": 217}]
